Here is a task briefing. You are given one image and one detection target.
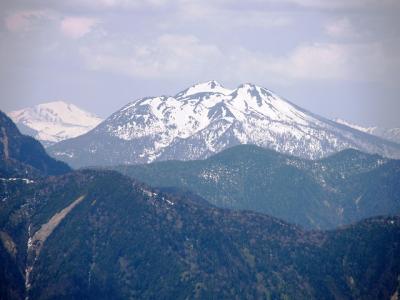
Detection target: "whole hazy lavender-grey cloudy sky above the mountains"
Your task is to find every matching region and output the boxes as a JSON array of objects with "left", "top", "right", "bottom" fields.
[{"left": 0, "top": 0, "right": 400, "bottom": 127}]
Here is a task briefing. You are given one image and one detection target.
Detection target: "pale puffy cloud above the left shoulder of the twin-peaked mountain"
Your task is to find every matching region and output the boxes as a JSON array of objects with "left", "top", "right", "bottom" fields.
[{"left": 81, "top": 35, "right": 223, "bottom": 78}]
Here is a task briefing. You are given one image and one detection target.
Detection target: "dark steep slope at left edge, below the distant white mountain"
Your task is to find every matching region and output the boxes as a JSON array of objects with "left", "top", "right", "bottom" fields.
[{"left": 0, "top": 111, "right": 70, "bottom": 180}]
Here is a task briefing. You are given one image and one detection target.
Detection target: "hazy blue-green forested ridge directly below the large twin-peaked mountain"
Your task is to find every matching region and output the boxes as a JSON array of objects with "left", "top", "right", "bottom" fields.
[{"left": 114, "top": 145, "right": 400, "bottom": 228}]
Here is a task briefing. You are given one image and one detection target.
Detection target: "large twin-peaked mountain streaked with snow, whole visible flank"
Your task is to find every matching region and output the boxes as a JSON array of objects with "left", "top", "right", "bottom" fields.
[{"left": 49, "top": 81, "right": 400, "bottom": 167}]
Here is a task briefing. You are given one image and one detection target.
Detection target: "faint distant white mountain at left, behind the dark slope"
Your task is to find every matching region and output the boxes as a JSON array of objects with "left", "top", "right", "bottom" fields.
[{"left": 8, "top": 101, "right": 103, "bottom": 146}]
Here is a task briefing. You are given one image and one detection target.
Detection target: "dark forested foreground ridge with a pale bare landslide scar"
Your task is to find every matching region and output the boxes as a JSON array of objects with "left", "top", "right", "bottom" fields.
[{"left": 0, "top": 171, "right": 400, "bottom": 299}]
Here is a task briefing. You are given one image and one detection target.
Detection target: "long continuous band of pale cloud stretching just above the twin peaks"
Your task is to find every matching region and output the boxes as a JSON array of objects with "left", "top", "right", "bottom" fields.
[{"left": 81, "top": 31, "right": 400, "bottom": 83}]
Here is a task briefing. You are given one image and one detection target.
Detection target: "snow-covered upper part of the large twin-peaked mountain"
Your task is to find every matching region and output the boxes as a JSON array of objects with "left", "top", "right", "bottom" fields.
[{"left": 99, "top": 81, "right": 310, "bottom": 147}]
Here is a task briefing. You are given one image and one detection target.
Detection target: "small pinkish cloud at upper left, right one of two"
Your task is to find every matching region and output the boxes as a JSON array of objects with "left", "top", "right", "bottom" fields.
[{"left": 60, "top": 17, "right": 99, "bottom": 39}]
